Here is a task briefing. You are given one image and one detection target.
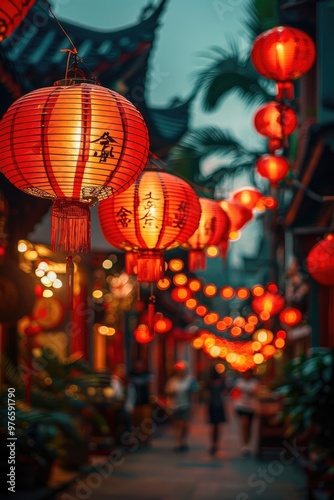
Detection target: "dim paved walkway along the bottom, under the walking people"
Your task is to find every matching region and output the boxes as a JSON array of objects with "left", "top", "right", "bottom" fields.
[{"left": 57, "top": 406, "right": 307, "bottom": 500}]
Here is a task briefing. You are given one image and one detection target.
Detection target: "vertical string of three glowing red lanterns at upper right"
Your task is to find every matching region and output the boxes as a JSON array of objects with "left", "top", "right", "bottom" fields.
[{"left": 251, "top": 26, "right": 316, "bottom": 187}]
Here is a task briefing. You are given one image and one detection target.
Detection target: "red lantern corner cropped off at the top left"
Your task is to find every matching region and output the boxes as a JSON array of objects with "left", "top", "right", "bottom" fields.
[{"left": 0, "top": 0, "right": 35, "bottom": 42}]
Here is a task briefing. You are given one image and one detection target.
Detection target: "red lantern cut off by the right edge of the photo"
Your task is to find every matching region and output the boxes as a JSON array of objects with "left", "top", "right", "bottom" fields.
[{"left": 306, "top": 234, "right": 334, "bottom": 286}]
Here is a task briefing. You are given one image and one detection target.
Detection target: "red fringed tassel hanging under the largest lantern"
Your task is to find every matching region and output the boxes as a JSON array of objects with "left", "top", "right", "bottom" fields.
[{"left": 51, "top": 199, "right": 90, "bottom": 252}]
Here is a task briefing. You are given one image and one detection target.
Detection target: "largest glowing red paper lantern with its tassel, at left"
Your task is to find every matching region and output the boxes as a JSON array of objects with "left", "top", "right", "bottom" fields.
[{"left": 0, "top": 80, "right": 149, "bottom": 252}]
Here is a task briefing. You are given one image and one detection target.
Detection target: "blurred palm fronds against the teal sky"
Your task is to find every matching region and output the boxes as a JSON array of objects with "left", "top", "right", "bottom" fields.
[{"left": 169, "top": 5, "right": 273, "bottom": 189}]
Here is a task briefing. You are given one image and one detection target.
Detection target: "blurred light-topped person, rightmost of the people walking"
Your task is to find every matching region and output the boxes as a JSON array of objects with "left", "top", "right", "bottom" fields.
[{"left": 234, "top": 370, "right": 260, "bottom": 455}]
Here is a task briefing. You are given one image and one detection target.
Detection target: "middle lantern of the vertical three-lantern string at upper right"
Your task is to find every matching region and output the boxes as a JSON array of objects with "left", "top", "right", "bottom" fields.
[{"left": 254, "top": 101, "right": 297, "bottom": 153}]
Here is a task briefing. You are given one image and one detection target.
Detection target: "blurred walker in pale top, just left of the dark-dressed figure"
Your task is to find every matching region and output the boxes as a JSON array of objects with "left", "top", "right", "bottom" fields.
[{"left": 165, "top": 361, "right": 198, "bottom": 451}]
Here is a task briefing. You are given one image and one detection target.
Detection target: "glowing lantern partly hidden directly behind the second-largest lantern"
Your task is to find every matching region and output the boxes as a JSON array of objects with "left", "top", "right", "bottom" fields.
[{"left": 182, "top": 198, "right": 231, "bottom": 272}]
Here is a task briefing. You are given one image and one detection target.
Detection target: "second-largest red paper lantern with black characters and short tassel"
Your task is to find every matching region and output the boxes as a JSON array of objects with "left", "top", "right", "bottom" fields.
[{"left": 98, "top": 167, "right": 201, "bottom": 282}]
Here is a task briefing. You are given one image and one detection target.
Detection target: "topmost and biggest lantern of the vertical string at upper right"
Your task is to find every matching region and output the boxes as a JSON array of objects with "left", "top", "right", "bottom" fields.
[{"left": 251, "top": 26, "right": 316, "bottom": 100}]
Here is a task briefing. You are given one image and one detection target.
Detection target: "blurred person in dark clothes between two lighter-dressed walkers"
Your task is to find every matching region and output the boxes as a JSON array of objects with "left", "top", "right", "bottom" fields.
[{"left": 206, "top": 366, "right": 226, "bottom": 455}]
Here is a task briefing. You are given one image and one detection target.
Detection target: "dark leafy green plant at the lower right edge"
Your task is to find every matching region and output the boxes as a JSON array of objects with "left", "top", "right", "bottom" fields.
[{"left": 277, "top": 347, "right": 334, "bottom": 498}]
